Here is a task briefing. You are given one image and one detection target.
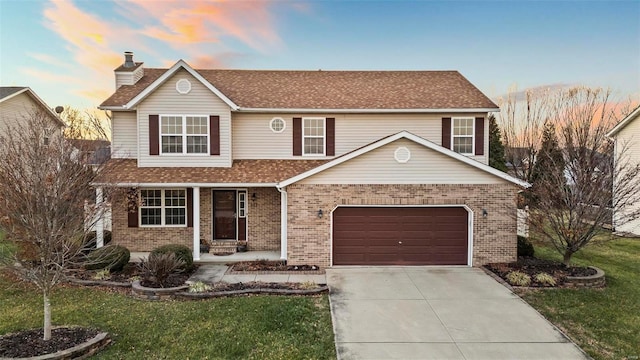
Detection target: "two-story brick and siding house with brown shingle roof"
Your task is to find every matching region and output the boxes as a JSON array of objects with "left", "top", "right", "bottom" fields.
[{"left": 96, "top": 53, "right": 529, "bottom": 267}]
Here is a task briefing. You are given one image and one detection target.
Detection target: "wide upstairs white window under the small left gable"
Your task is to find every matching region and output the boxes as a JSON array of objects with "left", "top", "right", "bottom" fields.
[{"left": 160, "top": 115, "right": 209, "bottom": 154}]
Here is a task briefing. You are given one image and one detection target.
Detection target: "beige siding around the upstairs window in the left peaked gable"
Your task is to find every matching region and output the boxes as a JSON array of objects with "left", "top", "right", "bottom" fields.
[{"left": 137, "top": 70, "right": 231, "bottom": 167}]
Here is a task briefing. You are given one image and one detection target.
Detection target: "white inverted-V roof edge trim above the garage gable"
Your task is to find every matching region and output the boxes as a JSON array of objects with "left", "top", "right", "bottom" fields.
[{"left": 278, "top": 131, "right": 531, "bottom": 188}]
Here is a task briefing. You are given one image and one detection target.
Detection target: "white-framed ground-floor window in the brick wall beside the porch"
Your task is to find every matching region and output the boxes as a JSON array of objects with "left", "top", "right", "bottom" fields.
[{"left": 140, "top": 189, "right": 187, "bottom": 226}]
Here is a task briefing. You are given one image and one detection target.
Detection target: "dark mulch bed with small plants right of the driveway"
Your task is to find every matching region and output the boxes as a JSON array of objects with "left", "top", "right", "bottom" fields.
[{"left": 485, "top": 257, "right": 596, "bottom": 287}]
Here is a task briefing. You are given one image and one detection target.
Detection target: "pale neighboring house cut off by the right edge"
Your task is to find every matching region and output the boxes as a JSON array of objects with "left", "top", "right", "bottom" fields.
[{"left": 607, "top": 106, "right": 640, "bottom": 236}]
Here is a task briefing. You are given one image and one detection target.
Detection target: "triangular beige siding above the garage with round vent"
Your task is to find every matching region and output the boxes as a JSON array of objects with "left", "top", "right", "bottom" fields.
[{"left": 300, "top": 139, "right": 506, "bottom": 184}]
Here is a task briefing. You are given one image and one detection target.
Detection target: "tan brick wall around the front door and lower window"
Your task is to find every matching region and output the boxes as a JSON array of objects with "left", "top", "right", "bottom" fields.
[{"left": 112, "top": 188, "right": 280, "bottom": 251}]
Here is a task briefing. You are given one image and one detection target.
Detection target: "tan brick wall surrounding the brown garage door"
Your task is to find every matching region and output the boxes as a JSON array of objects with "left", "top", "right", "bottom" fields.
[{"left": 287, "top": 183, "right": 519, "bottom": 267}]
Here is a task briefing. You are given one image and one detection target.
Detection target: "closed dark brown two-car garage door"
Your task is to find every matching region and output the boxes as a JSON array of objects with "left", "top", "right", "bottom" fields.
[{"left": 333, "top": 207, "right": 468, "bottom": 265}]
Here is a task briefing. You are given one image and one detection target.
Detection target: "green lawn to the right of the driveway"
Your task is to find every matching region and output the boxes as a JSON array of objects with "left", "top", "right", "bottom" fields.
[{"left": 522, "top": 233, "right": 640, "bottom": 359}]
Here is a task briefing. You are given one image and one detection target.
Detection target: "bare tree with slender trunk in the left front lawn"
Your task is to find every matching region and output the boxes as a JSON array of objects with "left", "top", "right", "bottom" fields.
[{"left": 0, "top": 112, "right": 109, "bottom": 340}]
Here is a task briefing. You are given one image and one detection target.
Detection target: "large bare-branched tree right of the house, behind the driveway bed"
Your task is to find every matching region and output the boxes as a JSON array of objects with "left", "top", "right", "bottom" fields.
[{"left": 529, "top": 87, "right": 640, "bottom": 264}]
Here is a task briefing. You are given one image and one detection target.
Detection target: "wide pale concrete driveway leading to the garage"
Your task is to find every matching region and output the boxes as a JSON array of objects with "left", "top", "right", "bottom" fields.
[{"left": 327, "top": 267, "right": 588, "bottom": 360}]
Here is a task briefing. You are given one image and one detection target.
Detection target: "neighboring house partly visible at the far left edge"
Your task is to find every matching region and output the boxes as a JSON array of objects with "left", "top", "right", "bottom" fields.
[{"left": 0, "top": 86, "right": 65, "bottom": 142}]
